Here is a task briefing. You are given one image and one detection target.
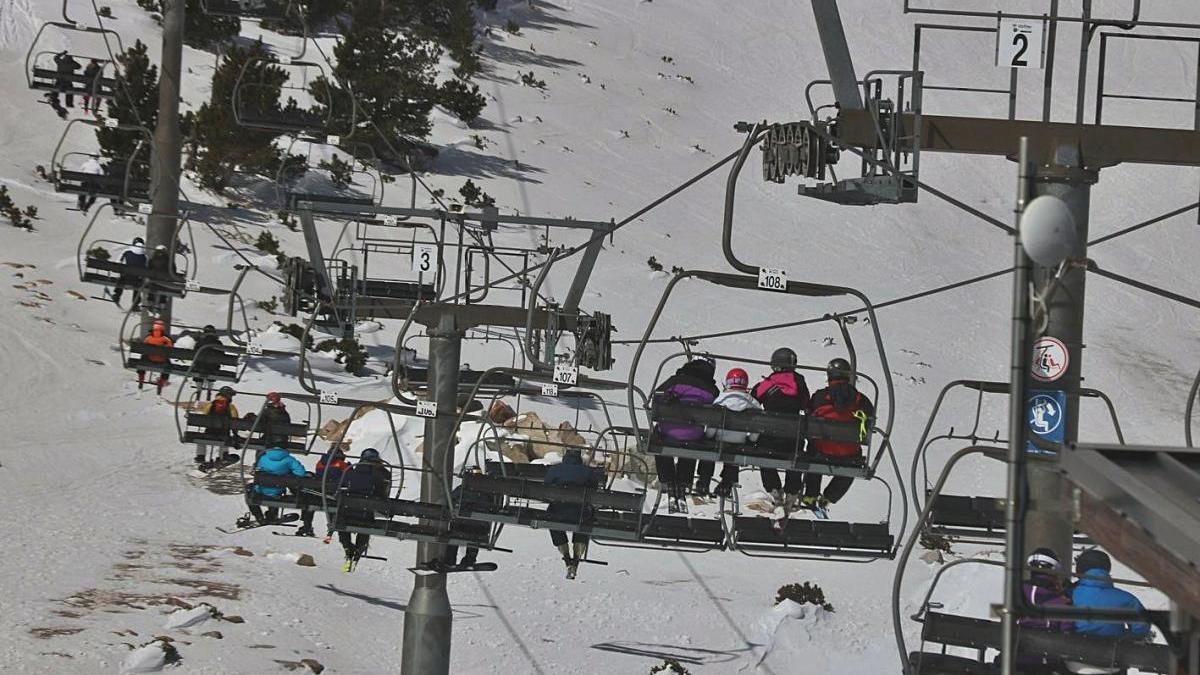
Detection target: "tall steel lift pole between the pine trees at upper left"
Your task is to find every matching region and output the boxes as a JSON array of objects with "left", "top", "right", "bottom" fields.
[{"left": 142, "top": 0, "right": 186, "bottom": 334}]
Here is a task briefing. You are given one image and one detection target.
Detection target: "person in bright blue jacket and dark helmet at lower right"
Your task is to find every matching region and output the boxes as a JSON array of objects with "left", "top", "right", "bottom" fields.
[{"left": 1067, "top": 549, "right": 1150, "bottom": 674}]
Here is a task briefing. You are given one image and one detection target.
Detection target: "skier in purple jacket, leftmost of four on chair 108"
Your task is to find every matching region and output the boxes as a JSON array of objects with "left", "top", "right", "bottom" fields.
[{"left": 654, "top": 358, "right": 720, "bottom": 513}]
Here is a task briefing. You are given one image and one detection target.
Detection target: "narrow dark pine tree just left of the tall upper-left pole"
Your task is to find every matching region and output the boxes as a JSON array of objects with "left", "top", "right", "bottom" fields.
[{"left": 96, "top": 40, "right": 158, "bottom": 180}]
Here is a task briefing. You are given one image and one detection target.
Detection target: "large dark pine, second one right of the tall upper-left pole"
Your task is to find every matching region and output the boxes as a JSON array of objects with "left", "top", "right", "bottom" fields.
[{"left": 312, "top": 0, "right": 440, "bottom": 161}]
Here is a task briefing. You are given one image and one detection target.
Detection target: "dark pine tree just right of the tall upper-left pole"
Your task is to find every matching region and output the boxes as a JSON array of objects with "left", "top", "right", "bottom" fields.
[{"left": 188, "top": 41, "right": 295, "bottom": 192}]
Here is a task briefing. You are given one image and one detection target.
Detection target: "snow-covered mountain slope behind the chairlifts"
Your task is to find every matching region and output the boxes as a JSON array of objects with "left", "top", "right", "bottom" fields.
[{"left": 0, "top": 0, "right": 1200, "bottom": 674}]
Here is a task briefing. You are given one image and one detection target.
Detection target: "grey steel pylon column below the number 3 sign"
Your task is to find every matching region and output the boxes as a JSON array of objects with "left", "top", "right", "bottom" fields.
[{"left": 400, "top": 312, "right": 463, "bottom": 675}]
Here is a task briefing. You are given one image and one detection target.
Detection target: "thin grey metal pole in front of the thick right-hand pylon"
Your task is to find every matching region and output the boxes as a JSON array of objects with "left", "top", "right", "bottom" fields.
[{"left": 1000, "top": 137, "right": 1033, "bottom": 675}]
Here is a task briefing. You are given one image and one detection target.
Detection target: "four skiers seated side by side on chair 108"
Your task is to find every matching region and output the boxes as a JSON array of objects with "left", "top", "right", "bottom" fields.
[{"left": 654, "top": 347, "right": 875, "bottom": 512}]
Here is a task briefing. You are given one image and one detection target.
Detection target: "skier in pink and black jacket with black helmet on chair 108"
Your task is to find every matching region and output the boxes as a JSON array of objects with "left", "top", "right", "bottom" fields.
[{"left": 751, "top": 347, "right": 809, "bottom": 512}]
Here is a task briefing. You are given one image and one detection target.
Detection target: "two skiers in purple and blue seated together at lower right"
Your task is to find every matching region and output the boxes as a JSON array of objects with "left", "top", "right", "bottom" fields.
[{"left": 1018, "top": 548, "right": 1150, "bottom": 675}]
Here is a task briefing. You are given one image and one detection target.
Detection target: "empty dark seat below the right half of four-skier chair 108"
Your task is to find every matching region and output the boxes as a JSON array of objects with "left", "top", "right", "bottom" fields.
[{"left": 733, "top": 515, "right": 895, "bottom": 557}]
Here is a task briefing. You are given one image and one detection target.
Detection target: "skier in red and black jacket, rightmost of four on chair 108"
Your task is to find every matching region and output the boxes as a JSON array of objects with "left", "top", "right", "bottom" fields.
[{"left": 800, "top": 358, "right": 875, "bottom": 510}]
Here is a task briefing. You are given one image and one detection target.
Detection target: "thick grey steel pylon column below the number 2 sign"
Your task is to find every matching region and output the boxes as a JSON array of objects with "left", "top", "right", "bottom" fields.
[{"left": 1024, "top": 154, "right": 1098, "bottom": 565}]
